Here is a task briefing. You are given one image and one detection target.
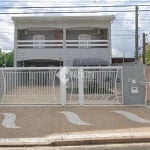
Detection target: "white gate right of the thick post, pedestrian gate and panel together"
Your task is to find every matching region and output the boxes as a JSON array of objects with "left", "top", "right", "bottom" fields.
[{"left": 66, "top": 67, "right": 123, "bottom": 105}]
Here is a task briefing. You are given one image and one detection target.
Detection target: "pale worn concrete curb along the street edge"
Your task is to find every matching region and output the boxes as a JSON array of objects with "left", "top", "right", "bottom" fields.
[{"left": 0, "top": 132, "right": 150, "bottom": 147}]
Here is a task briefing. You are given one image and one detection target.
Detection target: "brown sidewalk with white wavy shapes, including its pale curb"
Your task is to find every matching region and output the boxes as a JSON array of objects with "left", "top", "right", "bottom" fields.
[{"left": 0, "top": 106, "right": 150, "bottom": 146}]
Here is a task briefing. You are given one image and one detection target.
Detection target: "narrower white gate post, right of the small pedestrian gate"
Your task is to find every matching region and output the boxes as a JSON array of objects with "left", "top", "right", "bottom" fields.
[{"left": 78, "top": 68, "right": 84, "bottom": 105}]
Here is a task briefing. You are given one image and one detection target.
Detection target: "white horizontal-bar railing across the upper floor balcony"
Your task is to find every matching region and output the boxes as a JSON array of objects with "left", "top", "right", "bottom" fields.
[{"left": 17, "top": 40, "right": 108, "bottom": 48}]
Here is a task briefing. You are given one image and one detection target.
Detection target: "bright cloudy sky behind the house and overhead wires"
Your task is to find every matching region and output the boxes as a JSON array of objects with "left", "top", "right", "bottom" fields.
[{"left": 0, "top": 0, "right": 150, "bottom": 56}]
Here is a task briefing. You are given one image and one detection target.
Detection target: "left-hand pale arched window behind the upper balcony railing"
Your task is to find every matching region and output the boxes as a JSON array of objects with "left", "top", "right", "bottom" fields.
[{"left": 33, "top": 35, "right": 45, "bottom": 48}]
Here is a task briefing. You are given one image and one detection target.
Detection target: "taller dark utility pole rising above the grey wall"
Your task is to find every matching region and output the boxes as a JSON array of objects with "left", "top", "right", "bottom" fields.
[{"left": 135, "top": 6, "right": 139, "bottom": 63}]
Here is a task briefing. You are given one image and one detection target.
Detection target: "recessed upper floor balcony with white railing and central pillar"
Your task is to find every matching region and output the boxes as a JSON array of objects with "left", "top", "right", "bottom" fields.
[{"left": 16, "top": 28, "right": 109, "bottom": 49}]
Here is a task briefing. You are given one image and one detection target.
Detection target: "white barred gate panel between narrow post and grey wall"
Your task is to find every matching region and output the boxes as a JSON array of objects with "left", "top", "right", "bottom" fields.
[{"left": 84, "top": 67, "right": 123, "bottom": 104}]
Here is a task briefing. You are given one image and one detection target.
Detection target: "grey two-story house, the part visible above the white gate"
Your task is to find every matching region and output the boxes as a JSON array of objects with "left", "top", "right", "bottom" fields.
[{"left": 12, "top": 15, "right": 115, "bottom": 67}]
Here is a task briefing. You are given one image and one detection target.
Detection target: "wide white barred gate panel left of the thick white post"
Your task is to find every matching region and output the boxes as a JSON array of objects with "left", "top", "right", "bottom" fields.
[{"left": 2, "top": 68, "right": 60, "bottom": 104}]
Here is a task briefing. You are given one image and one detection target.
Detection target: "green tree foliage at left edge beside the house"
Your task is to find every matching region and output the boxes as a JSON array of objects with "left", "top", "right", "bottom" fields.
[{"left": 0, "top": 49, "right": 14, "bottom": 67}]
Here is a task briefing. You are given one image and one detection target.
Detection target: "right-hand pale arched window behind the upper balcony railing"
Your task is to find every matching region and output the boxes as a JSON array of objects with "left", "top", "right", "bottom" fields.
[{"left": 78, "top": 34, "right": 90, "bottom": 48}]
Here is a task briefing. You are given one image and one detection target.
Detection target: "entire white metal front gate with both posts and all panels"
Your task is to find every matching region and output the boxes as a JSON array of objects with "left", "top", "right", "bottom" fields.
[{"left": 0, "top": 67, "right": 123, "bottom": 105}]
